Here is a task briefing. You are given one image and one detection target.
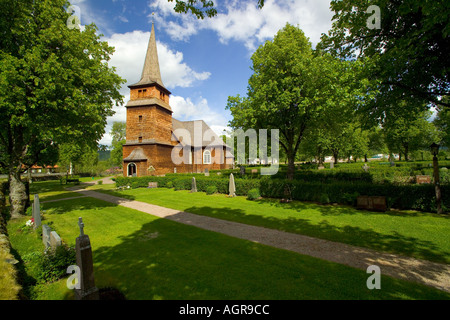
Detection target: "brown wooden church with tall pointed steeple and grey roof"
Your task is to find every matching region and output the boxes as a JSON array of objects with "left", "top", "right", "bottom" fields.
[{"left": 123, "top": 24, "right": 234, "bottom": 177}]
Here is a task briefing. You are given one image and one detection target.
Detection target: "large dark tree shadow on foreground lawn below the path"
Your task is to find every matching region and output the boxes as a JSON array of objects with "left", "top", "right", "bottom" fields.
[{"left": 63, "top": 218, "right": 449, "bottom": 300}]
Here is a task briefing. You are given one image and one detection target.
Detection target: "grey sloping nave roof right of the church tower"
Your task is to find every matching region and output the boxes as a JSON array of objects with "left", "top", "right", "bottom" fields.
[{"left": 172, "top": 118, "right": 228, "bottom": 147}]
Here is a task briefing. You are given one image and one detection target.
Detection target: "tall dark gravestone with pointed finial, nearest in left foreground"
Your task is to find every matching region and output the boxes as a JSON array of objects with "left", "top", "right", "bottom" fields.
[{"left": 75, "top": 218, "right": 99, "bottom": 300}]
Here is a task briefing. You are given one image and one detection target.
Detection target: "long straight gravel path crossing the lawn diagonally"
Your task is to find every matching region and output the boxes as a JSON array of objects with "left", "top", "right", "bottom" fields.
[{"left": 70, "top": 181, "right": 450, "bottom": 292}]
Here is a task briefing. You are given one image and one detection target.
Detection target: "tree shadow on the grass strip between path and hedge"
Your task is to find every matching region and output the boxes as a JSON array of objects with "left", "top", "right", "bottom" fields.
[{"left": 180, "top": 203, "right": 450, "bottom": 263}]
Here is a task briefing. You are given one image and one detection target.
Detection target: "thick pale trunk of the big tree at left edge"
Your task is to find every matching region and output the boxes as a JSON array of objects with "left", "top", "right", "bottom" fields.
[{"left": 9, "top": 167, "right": 29, "bottom": 219}]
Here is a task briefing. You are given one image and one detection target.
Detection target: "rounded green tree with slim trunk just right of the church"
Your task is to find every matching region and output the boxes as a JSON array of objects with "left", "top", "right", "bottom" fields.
[{"left": 227, "top": 24, "right": 363, "bottom": 179}]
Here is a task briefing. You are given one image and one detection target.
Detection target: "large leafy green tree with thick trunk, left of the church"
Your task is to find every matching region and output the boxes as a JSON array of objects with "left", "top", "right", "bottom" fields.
[{"left": 0, "top": 0, "right": 124, "bottom": 217}]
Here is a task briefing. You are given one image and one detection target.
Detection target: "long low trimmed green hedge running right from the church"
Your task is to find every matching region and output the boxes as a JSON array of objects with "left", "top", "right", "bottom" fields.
[{"left": 116, "top": 176, "right": 450, "bottom": 212}]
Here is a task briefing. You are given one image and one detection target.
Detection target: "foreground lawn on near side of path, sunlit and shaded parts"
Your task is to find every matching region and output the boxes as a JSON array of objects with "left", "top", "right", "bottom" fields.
[{"left": 8, "top": 198, "right": 450, "bottom": 299}]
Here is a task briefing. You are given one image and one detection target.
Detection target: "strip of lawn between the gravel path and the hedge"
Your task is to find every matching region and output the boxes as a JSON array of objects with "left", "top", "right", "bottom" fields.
[{"left": 91, "top": 186, "right": 450, "bottom": 263}]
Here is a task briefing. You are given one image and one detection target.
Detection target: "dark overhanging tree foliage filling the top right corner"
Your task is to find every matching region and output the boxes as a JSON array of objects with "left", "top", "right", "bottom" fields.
[{"left": 319, "top": 0, "right": 450, "bottom": 117}]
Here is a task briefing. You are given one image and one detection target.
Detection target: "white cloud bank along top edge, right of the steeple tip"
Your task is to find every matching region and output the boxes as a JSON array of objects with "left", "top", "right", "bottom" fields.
[{"left": 150, "top": 0, "right": 332, "bottom": 51}]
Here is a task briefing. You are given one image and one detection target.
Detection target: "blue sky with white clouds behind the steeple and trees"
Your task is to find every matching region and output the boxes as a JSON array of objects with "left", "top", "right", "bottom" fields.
[{"left": 71, "top": 0, "right": 332, "bottom": 145}]
